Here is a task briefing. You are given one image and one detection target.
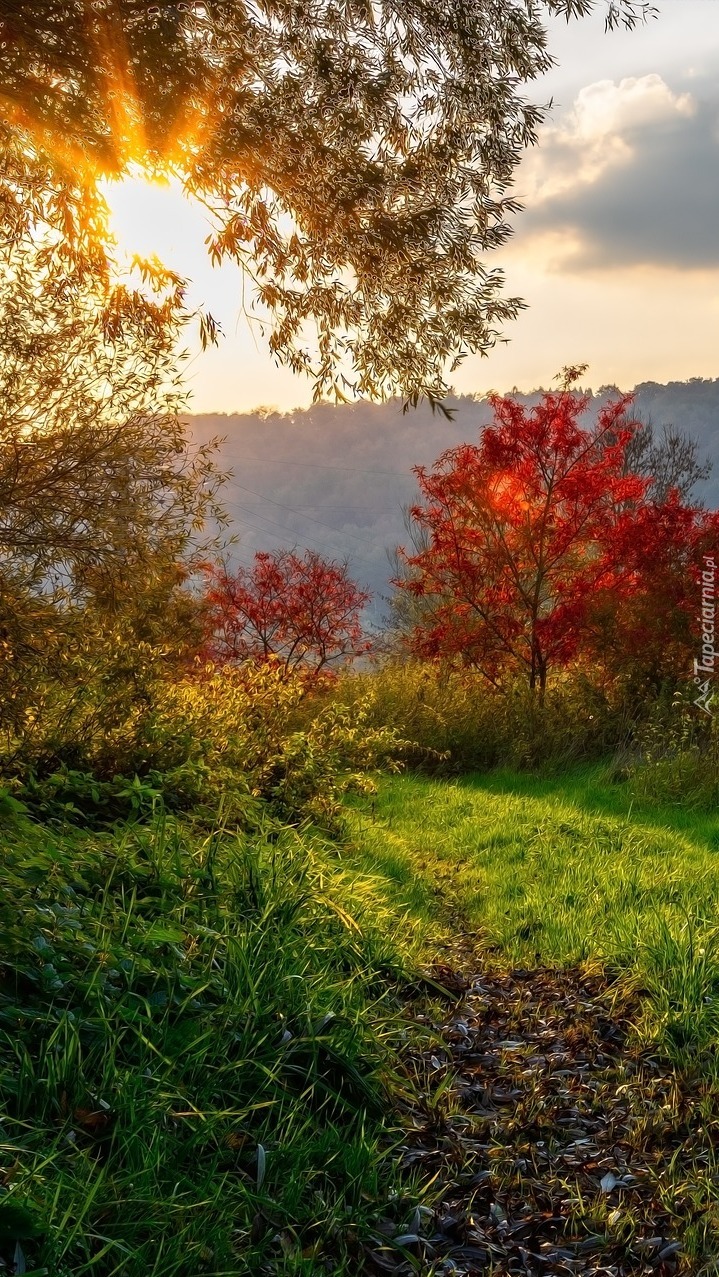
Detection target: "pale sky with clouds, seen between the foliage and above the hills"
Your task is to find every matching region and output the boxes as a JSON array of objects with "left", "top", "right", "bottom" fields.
[{"left": 110, "top": 0, "right": 719, "bottom": 412}]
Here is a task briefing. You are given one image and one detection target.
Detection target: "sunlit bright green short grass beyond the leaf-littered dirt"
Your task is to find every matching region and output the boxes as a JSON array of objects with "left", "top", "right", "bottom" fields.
[{"left": 352, "top": 767, "right": 719, "bottom": 1062}]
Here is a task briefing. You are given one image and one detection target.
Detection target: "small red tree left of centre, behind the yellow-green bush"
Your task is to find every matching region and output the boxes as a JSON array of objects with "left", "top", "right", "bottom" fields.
[{"left": 206, "top": 550, "right": 369, "bottom": 674}]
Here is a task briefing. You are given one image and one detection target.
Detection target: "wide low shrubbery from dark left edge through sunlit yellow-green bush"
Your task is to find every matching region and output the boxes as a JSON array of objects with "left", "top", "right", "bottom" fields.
[{"left": 5, "top": 665, "right": 402, "bottom": 831}]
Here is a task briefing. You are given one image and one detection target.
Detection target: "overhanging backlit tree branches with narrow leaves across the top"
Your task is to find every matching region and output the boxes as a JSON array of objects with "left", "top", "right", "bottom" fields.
[{"left": 0, "top": 0, "right": 650, "bottom": 402}]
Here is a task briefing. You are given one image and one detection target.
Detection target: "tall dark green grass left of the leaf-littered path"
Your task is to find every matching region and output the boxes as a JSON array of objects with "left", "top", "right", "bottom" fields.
[{"left": 0, "top": 816, "right": 423, "bottom": 1277}]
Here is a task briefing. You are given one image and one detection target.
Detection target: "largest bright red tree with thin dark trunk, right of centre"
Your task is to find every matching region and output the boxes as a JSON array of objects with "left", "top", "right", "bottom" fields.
[{"left": 397, "top": 382, "right": 650, "bottom": 693}]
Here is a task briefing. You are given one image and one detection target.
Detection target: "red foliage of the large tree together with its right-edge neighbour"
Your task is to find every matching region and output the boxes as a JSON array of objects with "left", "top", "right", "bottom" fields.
[{"left": 397, "top": 386, "right": 719, "bottom": 691}]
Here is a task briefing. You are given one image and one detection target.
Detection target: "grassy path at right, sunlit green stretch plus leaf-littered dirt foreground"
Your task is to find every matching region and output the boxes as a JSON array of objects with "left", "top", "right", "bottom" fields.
[{"left": 352, "top": 769, "right": 719, "bottom": 1277}]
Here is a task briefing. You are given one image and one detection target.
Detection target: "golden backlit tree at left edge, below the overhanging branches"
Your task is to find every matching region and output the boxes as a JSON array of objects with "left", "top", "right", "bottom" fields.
[{"left": 0, "top": 137, "right": 221, "bottom": 594}]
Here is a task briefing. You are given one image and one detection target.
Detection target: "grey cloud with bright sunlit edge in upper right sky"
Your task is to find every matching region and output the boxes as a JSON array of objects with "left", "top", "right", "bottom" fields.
[{"left": 517, "top": 74, "right": 719, "bottom": 271}]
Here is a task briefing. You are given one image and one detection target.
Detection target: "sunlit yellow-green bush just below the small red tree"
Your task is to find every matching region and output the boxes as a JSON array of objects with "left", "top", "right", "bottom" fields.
[{"left": 132, "top": 664, "right": 401, "bottom": 827}]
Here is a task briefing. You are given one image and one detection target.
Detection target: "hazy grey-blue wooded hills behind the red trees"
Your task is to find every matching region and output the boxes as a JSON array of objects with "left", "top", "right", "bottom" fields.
[{"left": 189, "top": 378, "right": 719, "bottom": 622}]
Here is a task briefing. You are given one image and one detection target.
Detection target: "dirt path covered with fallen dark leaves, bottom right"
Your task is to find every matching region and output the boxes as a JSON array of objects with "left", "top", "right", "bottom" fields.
[{"left": 367, "top": 968, "right": 719, "bottom": 1277}]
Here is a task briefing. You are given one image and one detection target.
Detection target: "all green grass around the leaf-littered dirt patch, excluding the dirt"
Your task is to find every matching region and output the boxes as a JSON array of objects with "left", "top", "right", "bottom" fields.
[{"left": 8, "top": 750, "right": 719, "bottom": 1277}]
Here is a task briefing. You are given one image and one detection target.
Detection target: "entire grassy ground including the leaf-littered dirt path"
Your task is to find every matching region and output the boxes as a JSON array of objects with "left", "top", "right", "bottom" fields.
[{"left": 0, "top": 767, "right": 719, "bottom": 1277}]
